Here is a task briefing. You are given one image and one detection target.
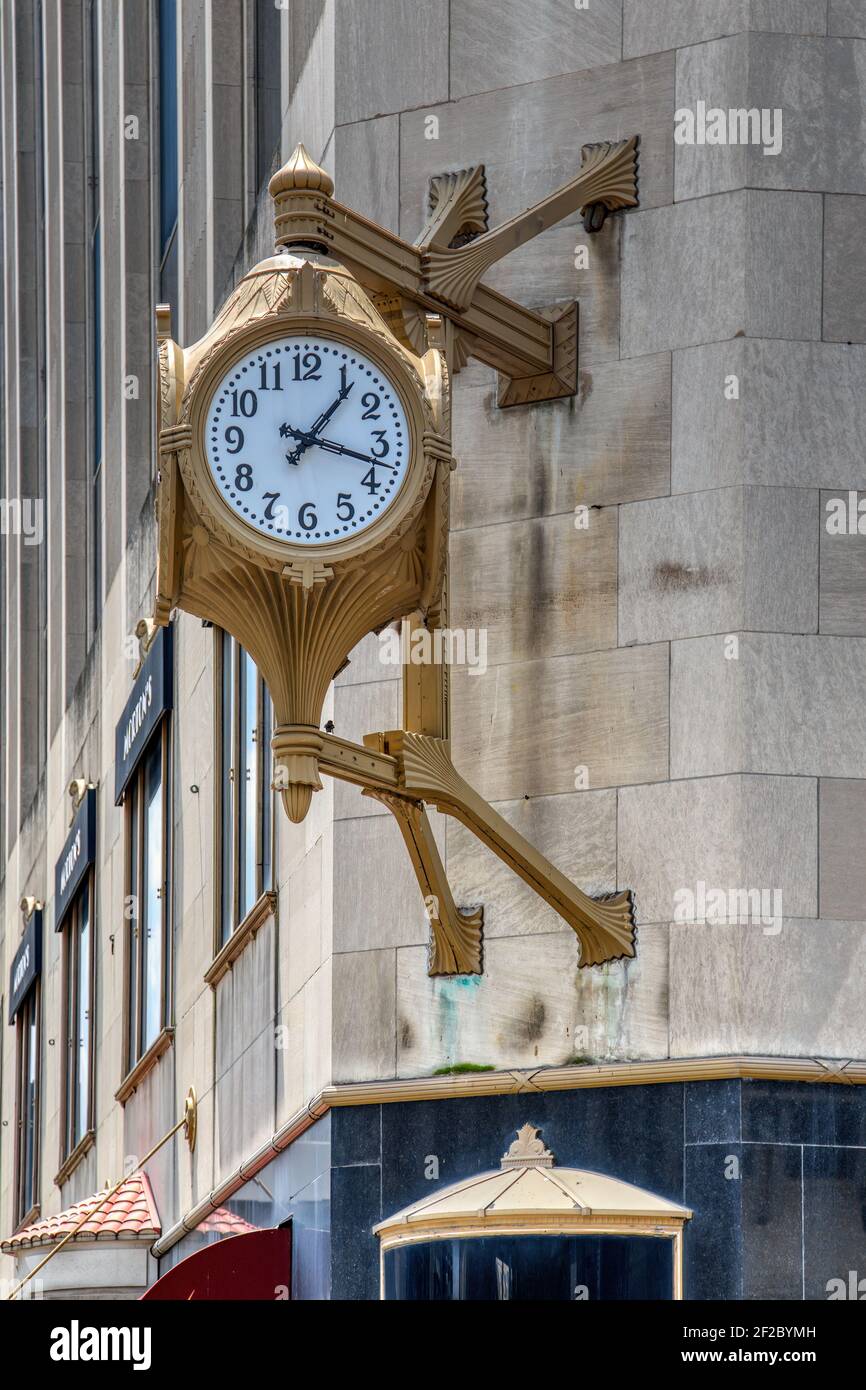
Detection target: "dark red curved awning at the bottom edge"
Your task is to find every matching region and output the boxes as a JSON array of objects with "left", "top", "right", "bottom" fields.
[{"left": 142, "top": 1225, "right": 292, "bottom": 1302}]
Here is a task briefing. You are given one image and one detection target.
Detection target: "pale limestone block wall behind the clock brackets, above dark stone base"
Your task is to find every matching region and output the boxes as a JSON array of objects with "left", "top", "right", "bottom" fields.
[{"left": 316, "top": 0, "right": 866, "bottom": 1080}]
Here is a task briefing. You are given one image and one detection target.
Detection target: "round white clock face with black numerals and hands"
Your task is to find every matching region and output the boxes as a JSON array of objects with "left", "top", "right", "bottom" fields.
[{"left": 204, "top": 334, "right": 410, "bottom": 546}]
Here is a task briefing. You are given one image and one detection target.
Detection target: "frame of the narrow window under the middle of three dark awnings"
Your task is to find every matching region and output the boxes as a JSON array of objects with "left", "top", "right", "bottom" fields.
[{"left": 54, "top": 869, "right": 96, "bottom": 1187}]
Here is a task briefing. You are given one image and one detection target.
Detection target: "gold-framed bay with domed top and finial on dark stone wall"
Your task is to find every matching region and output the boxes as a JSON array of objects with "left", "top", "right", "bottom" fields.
[{"left": 374, "top": 1125, "right": 692, "bottom": 1298}]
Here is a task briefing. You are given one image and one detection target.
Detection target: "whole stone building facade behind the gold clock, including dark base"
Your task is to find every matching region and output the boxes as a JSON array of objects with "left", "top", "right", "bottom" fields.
[{"left": 0, "top": 0, "right": 866, "bottom": 1300}]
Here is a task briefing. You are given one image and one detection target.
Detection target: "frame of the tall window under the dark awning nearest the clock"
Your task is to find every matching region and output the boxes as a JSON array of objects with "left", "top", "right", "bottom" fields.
[{"left": 115, "top": 714, "right": 174, "bottom": 1104}]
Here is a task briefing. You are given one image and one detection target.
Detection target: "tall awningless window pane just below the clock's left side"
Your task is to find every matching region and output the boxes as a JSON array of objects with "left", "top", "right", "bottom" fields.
[{"left": 218, "top": 632, "right": 274, "bottom": 947}]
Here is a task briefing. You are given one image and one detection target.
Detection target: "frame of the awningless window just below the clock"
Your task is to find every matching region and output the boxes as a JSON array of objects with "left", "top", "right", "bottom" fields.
[{"left": 209, "top": 627, "right": 277, "bottom": 961}]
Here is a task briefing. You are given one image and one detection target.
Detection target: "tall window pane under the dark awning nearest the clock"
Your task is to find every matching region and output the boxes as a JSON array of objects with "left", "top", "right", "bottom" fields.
[{"left": 125, "top": 720, "right": 171, "bottom": 1073}]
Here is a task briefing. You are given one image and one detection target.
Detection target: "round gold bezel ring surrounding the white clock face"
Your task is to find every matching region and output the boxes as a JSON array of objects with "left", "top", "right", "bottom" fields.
[{"left": 181, "top": 314, "right": 432, "bottom": 564}]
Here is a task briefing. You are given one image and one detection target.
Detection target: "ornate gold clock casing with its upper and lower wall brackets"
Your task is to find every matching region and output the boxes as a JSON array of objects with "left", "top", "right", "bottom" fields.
[{"left": 152, "top": 138, "right": 637, "bottom": 974}]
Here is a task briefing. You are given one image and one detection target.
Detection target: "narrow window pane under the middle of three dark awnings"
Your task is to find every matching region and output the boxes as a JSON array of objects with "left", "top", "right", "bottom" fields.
[{"left": 63, "top": 877, "right": 93, "bottom": 1158}]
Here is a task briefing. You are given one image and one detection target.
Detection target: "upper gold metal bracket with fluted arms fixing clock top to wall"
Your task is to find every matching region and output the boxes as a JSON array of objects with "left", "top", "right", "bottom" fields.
[{"left": 270, "top": 135, "right": 638, "bottom": 406}]
